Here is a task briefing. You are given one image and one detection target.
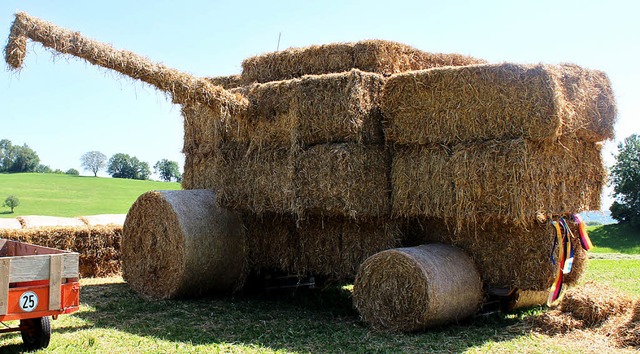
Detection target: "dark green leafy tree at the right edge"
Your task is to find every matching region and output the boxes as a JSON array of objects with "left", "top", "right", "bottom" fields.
[{"left": 609, "top": 134, "right": 640, "bottom": 228}]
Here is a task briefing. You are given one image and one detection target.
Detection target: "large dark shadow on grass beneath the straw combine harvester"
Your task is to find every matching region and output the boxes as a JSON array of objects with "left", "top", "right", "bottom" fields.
[{"left": 67, "top": 283, "right": 524, "bottom": 352}]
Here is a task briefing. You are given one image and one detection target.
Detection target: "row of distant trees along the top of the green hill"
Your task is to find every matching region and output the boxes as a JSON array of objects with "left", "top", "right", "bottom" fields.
[{"left": 0, "top": 139, "right": 182, "bottom": 182}]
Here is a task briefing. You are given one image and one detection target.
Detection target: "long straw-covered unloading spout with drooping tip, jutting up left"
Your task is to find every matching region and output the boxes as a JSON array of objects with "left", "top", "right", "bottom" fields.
[{"left": 4, "top": 12, "right": 248, "bottom": 114}]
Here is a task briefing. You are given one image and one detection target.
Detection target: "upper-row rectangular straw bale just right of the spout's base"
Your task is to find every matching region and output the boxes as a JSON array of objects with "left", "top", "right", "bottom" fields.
[{"left": 234, "top": 70, "right": 384, "bottom": 146}]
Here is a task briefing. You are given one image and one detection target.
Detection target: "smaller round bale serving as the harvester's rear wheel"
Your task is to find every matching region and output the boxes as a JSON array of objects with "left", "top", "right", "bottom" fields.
[{"left": 353, "top": 244, "right": 482, "bottom": 331}]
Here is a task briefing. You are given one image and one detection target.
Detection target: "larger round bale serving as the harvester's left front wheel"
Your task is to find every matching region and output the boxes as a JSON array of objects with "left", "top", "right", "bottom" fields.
[{"left": 122, "top": 190, "right": 246, "bottom": 299}]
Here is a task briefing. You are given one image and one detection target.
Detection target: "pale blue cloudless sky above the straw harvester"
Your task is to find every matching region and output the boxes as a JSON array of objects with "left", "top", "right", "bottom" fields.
[{"left": 0, "top": 0, "right": 640, "bottom": 207}]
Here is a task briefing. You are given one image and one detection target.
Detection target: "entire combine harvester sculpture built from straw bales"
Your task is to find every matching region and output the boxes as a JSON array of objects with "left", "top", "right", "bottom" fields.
[{"left": 5, "top": 13, "right": 616, "bottom": 331}]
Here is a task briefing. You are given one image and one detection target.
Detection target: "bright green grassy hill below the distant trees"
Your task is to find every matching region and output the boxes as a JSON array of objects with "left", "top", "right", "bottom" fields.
[{"left": 0, "top": 173, "right": 180, "bottom": 218}]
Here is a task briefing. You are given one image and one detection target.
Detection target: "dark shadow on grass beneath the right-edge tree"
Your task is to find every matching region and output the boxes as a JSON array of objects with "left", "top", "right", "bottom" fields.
[{"left": 589, "top": 224, "right": 640, "bottom": 254}]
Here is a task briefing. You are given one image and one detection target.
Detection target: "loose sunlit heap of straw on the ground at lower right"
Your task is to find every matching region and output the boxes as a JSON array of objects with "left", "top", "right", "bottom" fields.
[{"left": 560, "top": 281, "right": 633, "bottom": 326}]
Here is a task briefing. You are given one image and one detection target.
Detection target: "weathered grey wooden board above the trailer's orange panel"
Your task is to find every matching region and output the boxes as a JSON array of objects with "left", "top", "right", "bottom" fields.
[{"left": 9, "top": 253, "right": 80, "bottom": 283}]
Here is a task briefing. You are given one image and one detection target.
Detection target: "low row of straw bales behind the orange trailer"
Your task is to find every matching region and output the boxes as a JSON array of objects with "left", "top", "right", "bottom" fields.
[{"left": 0, "top": 225, "right": 122, "bottom": 277}]
